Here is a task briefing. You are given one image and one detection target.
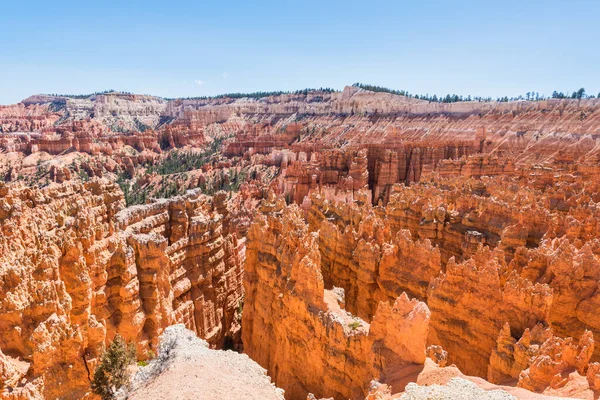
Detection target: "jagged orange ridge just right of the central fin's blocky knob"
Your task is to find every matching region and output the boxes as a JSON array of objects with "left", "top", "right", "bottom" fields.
[{"left": 427, "top": 249, "right": 552, "bottom": 375}]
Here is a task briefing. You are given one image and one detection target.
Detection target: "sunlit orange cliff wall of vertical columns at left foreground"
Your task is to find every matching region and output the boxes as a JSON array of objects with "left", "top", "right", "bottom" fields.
[{"left": 0, "top": 180, "right": 243, "bottom": 398}]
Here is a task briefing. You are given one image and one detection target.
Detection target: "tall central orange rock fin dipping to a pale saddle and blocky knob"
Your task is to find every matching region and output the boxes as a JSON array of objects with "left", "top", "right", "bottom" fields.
[{"left": 242, "top": 199, "right": 429, "bottom": 399}]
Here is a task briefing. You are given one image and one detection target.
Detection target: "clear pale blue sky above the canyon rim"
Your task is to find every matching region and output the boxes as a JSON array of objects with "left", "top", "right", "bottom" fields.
[{"left": 0, "top": 0, "right": 600, "bottom": 104}]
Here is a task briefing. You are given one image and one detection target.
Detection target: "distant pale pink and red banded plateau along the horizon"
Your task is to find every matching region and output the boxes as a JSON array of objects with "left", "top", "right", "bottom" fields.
[{"left": 5, "top": 87, "right": 600, "bottom": 195}]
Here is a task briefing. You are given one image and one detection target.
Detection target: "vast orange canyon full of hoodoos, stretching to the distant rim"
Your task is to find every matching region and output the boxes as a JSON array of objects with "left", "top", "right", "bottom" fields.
[{"left": 0, "top": 86, "right": 600, "bottom": 400}]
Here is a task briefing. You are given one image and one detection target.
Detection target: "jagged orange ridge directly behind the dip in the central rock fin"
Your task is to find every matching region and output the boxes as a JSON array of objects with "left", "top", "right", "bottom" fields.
[{"left": 308, "top": 194, "right": 441, "bottom": 320}]
